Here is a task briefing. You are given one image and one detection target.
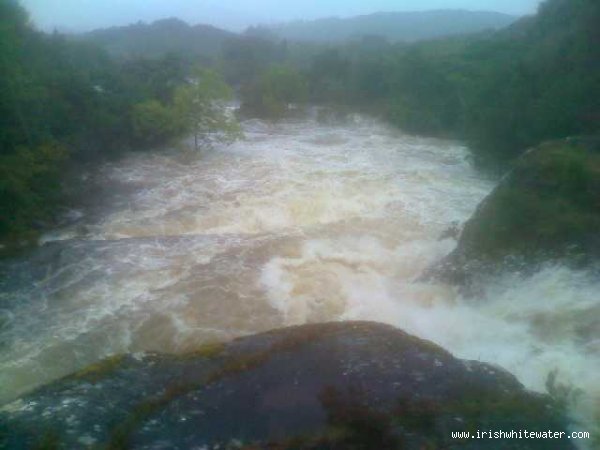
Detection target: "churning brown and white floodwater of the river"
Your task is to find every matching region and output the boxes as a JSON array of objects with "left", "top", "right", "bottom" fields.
[{"left": 0, "top": 116, "right": 600, "bottom": 434}]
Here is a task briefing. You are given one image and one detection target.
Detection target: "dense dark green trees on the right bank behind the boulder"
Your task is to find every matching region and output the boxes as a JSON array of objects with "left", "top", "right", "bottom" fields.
[{"left": 300, "top": 0, "right": 600, "bottom": 169}]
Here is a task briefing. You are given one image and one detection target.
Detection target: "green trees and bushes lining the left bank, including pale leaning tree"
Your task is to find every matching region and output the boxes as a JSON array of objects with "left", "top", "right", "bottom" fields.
[{"left": 0, "top": 0, "right": 235, "bottom": 246}]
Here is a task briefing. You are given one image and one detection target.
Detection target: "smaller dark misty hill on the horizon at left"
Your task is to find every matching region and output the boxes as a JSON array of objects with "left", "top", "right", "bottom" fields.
[{"left": 80, "top": 18, "right": 236, "bottom": 58}]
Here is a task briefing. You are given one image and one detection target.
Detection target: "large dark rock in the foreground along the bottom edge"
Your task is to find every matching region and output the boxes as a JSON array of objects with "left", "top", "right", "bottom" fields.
[{"left": 0, "top": 322, "right": 572, "bottom": 450}]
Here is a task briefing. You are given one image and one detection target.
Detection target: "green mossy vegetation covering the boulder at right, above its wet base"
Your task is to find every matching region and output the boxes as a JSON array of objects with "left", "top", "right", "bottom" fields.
[{"left": 461, "top": 142, "right": 600, "bottom": 261}]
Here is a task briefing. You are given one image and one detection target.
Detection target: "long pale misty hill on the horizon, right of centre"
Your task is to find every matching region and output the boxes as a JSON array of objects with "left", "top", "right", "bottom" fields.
[{"left": 270, "top": 10, "right": 517, "bottom": 42}]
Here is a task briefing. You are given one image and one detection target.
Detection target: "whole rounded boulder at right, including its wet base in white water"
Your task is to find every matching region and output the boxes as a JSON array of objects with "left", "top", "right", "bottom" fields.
[{"left": 432, "top": 138, "right": 600, "bottom": 285}]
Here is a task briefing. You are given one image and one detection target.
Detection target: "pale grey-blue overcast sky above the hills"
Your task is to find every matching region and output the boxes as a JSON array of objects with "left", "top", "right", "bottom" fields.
[{"left": 21, "top": 0, "right": 541, "bottom": 31}]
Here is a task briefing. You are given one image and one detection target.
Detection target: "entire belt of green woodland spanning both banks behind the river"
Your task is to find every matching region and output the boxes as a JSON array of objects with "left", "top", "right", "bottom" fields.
[{"left": 0, "top": 0, "right": 600, "bottom": 248}]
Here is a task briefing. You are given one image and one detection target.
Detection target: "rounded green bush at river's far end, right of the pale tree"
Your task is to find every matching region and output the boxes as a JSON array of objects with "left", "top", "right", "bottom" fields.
[{"left": 242, "top": 65, "right": 308, "bottom": 119}]
